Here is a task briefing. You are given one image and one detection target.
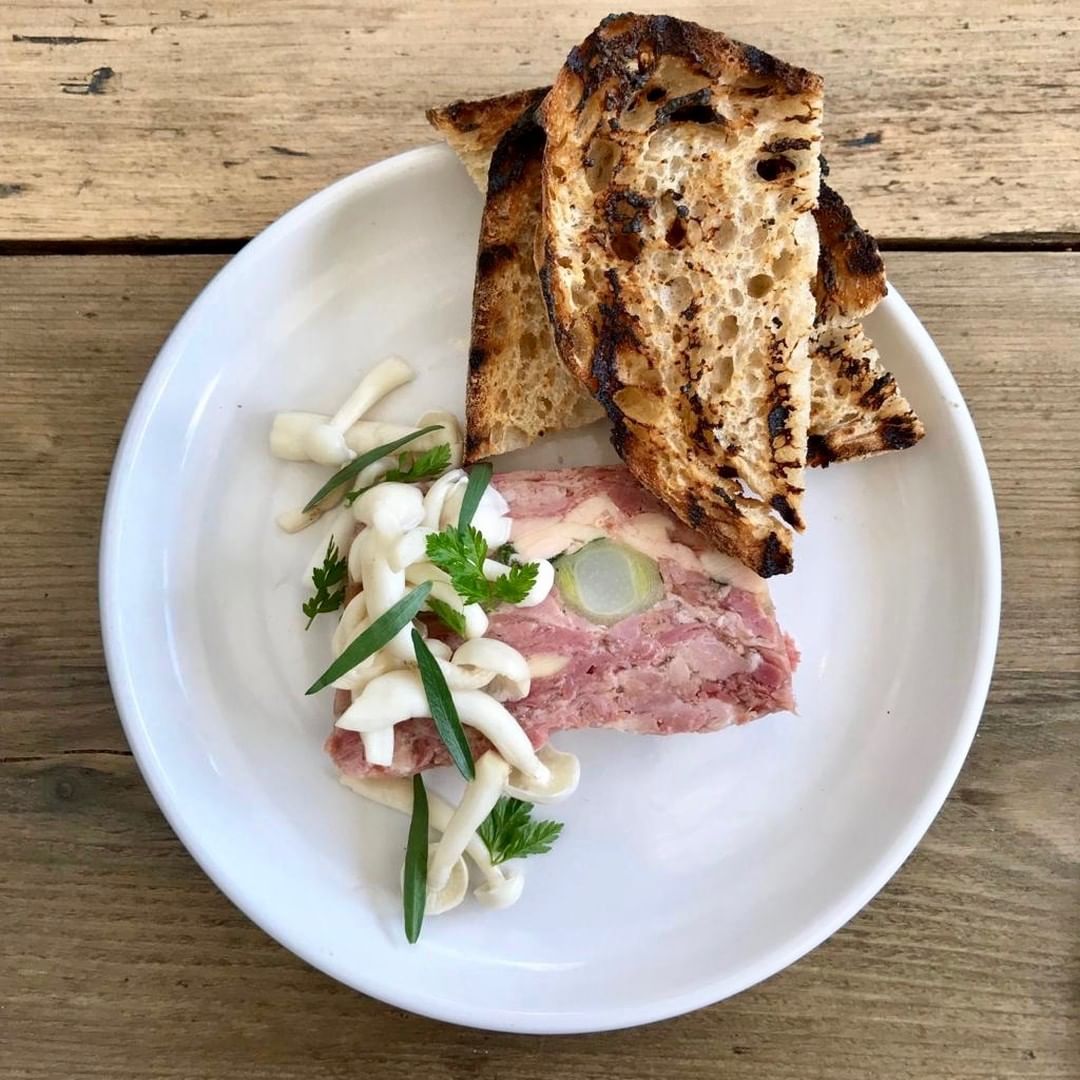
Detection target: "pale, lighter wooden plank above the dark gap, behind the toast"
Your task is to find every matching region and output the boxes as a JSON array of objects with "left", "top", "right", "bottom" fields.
[{"left": 0, "top": 0, "right": 1080, "bottom": 241}]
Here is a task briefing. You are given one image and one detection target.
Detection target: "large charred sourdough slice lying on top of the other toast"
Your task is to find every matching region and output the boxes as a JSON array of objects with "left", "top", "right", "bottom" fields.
[{"left": 538, "top": 15, "right": 823, "bottom": 577}]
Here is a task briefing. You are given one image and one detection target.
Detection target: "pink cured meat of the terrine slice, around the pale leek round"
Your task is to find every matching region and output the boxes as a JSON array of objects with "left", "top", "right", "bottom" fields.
[{"left": 326, "top": 468, "right": 798, "bottom": 777}]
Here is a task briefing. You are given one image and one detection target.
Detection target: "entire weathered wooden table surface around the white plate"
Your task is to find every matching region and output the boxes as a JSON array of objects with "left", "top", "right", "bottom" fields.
[{"left": 0, "top": 0, "right": 1080, "bottom": 1080}]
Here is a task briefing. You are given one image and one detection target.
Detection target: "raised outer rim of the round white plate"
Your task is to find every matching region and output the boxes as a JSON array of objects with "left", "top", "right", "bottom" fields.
[{"left": 98, "top": 144, "right": 1001, "bottom": 1035}]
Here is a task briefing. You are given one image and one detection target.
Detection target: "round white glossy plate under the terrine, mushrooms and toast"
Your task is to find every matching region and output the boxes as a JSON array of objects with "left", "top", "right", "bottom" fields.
[{"left": 102, "top": 148, "right": 999, "bottom": 1032}]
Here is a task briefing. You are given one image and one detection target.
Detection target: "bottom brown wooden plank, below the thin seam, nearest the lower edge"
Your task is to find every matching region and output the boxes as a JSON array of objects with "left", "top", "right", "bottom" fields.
[{"left": 0, "top": 673, "right": 1080, "bottom": 1080}]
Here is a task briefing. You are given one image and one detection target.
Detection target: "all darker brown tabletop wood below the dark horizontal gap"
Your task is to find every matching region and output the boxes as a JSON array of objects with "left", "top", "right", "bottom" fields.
[{"left": 0, "top": 254, "right": 1080, "bottom": 1080}]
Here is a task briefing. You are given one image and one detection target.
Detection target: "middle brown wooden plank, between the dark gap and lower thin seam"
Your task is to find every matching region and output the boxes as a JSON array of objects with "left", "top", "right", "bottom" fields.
[{"left": 0, "top": 254, "right": 1080, "bottom": 755}]
